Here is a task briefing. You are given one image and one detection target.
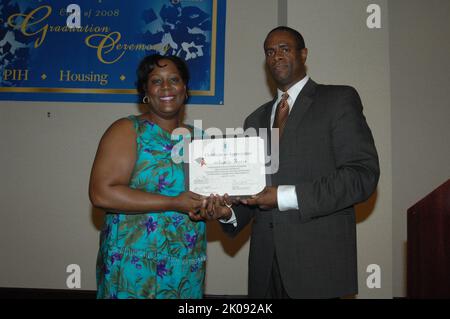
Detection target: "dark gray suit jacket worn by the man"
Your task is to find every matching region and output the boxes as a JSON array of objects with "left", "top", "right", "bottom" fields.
[{"left": 222, "top": 79, "right": 379, "bottom": 298}]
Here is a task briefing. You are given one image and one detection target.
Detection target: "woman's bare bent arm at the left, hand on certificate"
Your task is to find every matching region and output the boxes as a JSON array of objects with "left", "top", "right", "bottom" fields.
[{"left": 89, "top": 119, "right": 202, "bottom": 214}]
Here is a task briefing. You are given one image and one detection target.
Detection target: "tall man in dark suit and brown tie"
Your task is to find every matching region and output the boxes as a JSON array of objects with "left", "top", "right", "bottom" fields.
[{"left": 205, "top": 27, "right": 379, "bottom": 298}]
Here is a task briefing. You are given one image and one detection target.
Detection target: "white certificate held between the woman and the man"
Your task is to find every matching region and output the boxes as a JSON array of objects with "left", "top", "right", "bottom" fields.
[{"left": 188, "top": 136, "right": 266, "bottom": 196}]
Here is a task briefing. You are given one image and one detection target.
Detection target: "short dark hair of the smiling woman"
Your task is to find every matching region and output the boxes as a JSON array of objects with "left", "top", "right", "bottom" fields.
[{"left": 136, "top": 54, "right": 189, "bottom": 97}]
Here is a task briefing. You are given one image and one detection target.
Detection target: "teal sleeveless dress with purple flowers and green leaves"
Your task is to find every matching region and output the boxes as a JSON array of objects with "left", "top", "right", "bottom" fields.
[{"left": 96, "top": 116, "right": 206, "bottom": 299}]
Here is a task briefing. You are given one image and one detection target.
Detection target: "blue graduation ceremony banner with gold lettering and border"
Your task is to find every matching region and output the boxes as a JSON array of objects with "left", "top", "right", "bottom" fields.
[{"left": 0, "top": 0, "right": 226, "bottom": 104}]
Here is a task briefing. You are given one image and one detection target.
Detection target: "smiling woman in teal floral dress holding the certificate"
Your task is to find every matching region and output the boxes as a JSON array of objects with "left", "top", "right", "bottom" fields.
[{"left": 89, "top": 55, "right": 206, "bottom": 299}]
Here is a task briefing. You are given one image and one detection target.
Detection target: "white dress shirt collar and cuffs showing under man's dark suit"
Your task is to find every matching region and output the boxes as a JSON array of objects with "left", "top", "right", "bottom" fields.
[{"left": 219, "top": 76, "right": 309, "bottom": 226}]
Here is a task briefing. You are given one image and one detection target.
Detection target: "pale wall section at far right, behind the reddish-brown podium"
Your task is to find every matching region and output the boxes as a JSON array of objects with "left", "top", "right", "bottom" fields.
[{"left": 389, "top": 0, "right": 450, "bottom": 297}]
